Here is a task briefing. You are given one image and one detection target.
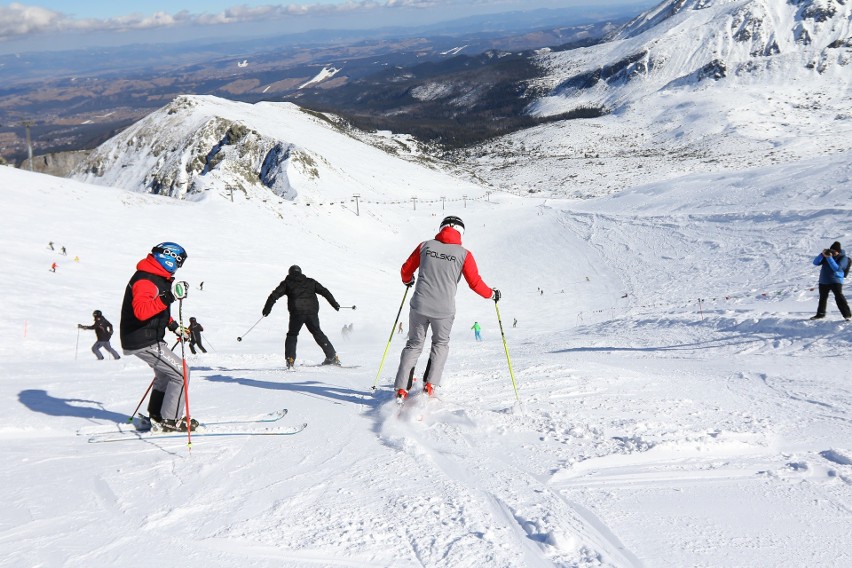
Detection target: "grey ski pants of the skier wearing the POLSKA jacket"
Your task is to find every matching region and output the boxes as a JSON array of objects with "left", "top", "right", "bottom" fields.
[{"left": 394, "top": 310, "right": 455, "bottom": 390}]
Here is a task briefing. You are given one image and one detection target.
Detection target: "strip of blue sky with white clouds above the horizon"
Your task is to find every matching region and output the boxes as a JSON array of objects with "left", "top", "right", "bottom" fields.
[{"left": 0, "top": 0, "right": 657, "bottom": 53}]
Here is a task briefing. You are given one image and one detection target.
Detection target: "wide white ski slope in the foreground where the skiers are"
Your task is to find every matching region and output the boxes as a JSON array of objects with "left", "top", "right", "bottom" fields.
[{"left": 0, "top": 141, "right": 852, "bottom": 568}]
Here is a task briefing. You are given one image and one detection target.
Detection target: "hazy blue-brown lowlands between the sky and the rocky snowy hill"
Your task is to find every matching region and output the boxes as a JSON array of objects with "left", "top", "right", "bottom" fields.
[{"left": 0, "top": 6, "right": 638, "bottom": 161}]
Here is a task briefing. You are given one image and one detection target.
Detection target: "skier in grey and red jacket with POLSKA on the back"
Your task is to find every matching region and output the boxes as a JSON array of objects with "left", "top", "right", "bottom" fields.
[{"left": 394, "top": 215, "right": 500, "bottom": 401}]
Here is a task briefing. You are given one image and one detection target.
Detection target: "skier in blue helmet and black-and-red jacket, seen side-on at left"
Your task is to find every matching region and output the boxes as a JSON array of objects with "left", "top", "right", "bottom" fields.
[{"left": 120, "top": 242, "right": 198, "bottom": 432}]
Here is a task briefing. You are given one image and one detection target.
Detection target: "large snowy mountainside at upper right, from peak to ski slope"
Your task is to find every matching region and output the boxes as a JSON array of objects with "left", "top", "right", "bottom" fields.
[{"left": 463, "top": 0, "right": 852, "bottom": 197}]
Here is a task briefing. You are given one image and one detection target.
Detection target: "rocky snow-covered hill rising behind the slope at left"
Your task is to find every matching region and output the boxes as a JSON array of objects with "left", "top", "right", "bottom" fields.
[{"left": 73, "top": 96, "right": 472, "bottom": 204}]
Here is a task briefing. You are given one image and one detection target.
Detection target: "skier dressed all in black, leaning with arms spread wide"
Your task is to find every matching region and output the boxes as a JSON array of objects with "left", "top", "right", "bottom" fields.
[{"left": 263, "top": 264, "right": 340, "bottom": 369}]
